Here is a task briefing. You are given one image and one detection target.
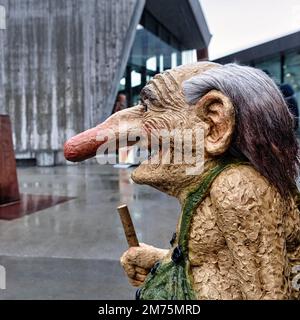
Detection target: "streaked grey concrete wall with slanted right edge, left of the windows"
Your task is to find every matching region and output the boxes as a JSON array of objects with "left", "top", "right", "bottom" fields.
[{"left": 2, "top": 0, "right": 144, "bottom": 165}]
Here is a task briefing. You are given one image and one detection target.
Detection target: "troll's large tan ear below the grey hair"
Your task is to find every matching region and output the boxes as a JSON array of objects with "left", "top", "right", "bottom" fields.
[{"left": 196, "top": 90, "right": 235, "bottom": 156}]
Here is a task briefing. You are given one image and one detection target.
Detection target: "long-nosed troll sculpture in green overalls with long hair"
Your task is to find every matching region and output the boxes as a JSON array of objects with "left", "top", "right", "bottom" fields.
[{"left": 65, "top": 62, "right": 300, "bottom": 299}]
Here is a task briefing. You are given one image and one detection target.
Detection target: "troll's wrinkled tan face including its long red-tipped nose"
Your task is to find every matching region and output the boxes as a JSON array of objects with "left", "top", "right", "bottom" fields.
[{"left": 65, "top": 62, "right": 233, "bottom": 195}]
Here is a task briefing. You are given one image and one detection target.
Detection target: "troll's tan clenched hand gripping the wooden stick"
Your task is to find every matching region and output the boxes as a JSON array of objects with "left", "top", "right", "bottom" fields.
[{"left": 120, "top": 243, "right": 168, "bottom": 287}]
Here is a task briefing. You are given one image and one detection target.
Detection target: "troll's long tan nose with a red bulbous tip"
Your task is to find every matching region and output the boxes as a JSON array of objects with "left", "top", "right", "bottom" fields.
[{"left": 64, "top": 106, "right": 144, "bottom": 162}]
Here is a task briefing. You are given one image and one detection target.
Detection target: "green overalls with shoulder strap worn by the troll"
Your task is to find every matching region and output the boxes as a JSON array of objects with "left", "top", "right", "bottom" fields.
[{"left": 136, "top": 159, "right": 243, "bottom": 300}]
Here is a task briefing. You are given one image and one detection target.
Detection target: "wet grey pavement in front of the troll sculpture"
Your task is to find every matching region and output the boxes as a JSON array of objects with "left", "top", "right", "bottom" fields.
[{"left": 0, "top": 164, "right": 179, "bottom": 299}]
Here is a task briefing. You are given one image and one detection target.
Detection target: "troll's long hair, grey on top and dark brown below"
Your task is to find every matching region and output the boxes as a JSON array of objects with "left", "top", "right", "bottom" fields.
[{"left": 183, "top": 64, "right": 299, "bottom": 196}]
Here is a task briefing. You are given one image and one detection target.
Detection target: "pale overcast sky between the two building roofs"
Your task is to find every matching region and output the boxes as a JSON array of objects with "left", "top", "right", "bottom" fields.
[{"left": 200, "top": 0, "right": 300, "bottom": 60}]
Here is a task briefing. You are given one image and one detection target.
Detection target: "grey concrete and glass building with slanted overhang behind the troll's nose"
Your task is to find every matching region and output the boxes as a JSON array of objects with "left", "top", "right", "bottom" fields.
[{"left": 1, "top": 0, "right": 210, "bottom": 165}]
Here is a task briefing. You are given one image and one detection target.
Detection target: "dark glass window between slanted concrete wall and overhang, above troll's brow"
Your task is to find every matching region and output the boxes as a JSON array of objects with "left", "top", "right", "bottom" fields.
[{"left": 119, "top": 11, "right": 197, "bottom": 106}]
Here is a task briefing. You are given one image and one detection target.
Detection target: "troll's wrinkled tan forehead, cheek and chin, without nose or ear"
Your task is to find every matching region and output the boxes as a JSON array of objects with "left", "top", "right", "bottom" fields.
[{"left": 132, "top": 64, "right": 210, "bottom": 194}]
